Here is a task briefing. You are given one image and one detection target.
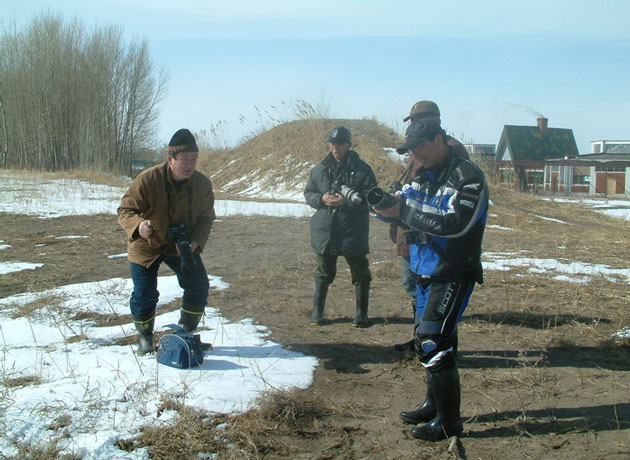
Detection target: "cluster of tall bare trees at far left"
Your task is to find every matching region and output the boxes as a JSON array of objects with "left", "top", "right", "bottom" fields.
[{"left": 0, "top": 14, "right": 168, "bottom": 174}]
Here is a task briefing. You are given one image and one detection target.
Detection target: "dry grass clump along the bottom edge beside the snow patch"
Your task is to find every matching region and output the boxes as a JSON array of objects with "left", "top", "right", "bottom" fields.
[{"left": 117, "top": 390, "right": 339, "bottom": 460}]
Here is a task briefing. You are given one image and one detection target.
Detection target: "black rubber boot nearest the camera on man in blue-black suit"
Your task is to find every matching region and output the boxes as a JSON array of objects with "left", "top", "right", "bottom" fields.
[{"left": 411, "top": 358, "right": 464, "bottom": 441}]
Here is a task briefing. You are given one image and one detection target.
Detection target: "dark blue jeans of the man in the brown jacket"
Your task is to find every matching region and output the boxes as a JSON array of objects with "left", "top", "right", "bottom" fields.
[{"left": 129, "top": 254, "right": 209, "bottom": 317}]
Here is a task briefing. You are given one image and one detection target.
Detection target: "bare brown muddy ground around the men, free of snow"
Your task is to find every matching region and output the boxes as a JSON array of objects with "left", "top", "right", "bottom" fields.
[{"left": 0, "top": 189, "right": 630, "bottom": 459}]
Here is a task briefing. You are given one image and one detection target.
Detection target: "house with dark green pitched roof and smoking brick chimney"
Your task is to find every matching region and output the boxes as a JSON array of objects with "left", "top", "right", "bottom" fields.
[{"left": 495, "top": 118, "right": 578, "bottom": 192}]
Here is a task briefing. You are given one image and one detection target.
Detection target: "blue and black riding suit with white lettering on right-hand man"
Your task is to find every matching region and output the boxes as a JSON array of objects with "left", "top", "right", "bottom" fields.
[{"left": 399, "top": 148, "right": 488, "bottom": 370}]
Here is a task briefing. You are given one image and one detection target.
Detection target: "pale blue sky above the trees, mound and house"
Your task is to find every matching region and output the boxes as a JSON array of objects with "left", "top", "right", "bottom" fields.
[{"left": 0, "top": 0, "right": 630, "bottom": 153}]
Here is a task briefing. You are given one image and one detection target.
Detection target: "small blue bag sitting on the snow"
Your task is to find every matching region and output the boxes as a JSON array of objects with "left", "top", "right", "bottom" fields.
[{"left": 156, "top": 324, "right": 204, "bottom": 369}]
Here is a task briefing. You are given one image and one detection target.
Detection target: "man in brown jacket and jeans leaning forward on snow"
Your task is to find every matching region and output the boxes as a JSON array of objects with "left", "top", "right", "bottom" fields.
[{"left": 118, "top": 129, "right": 215, "bottom": 355}]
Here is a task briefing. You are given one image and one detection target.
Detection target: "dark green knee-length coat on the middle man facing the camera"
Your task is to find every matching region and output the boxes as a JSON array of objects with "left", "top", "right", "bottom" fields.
[{"left": 304, "top": 150, "right": 377, "bottom": 256}]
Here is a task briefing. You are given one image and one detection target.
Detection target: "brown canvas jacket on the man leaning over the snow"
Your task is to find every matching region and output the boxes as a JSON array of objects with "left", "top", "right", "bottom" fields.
[{"left": 118, "top": 162, "right": 216, "bottom": 268}]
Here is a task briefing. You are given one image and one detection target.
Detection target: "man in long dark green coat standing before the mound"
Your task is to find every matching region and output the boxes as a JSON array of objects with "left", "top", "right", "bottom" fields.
[{"left": 304, "top": 126, "right": 376, "bottom": 327}]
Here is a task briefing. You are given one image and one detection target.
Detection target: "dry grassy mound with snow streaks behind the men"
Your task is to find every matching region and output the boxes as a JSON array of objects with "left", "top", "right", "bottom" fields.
[{"left": 198, "top": 119, "right": 402, "bottom": 201}]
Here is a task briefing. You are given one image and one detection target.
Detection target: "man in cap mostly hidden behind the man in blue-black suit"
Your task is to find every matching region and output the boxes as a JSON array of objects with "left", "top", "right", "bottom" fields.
[{"left": 396, "top": 101, "right": 469, "bottom": 351}]
